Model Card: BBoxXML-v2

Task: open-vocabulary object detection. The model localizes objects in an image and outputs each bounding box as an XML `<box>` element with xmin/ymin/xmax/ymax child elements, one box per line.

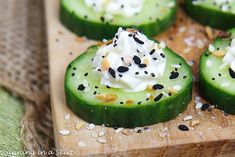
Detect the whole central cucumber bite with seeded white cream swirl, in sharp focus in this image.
<box><xmin>65</xmin><ymin>28</ymin><xmax>192</xmax><ymax>128</ymax></box>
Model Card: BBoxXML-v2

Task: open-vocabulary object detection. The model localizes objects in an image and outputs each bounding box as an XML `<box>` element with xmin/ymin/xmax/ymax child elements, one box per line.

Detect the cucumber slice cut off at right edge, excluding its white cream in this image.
<box><xmin>200</xmin><ymin>29</ymin><xmax>235</xmax><ymax>114</ymax></box>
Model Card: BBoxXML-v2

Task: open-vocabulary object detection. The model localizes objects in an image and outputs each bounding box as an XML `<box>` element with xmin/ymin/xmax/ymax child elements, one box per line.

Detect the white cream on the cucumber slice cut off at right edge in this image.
<box><xmin>221</xmin><ymin>38</ymin><xmax>235</xmax><ymax>71</ymax></box>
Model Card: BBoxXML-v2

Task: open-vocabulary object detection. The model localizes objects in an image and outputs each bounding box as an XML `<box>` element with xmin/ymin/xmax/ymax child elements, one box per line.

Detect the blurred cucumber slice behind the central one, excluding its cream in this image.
<box><xmin>60</xmin><ymin>0</ymin><xmax>176</xmax><ymax>40</ymax></box>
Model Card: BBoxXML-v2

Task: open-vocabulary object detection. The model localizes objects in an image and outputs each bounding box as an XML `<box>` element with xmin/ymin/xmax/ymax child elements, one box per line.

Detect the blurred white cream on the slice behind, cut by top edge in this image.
<box><xmin>85</xmin><ymin>0</ymin><xmax>144</xmax><ymax>18</ymax></box>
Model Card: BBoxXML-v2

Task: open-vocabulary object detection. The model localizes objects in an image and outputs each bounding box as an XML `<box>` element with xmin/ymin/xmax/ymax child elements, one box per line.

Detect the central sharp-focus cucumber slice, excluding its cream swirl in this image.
<box><xmin>65</xmin><ymin>46</ymin><xmax>192</xmax><ymax>128</ymax></box>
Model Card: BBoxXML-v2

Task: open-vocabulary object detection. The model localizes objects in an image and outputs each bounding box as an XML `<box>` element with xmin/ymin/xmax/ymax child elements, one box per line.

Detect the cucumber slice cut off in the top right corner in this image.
<box><xmin>184</xmin><ymin>0</ymin><xmax>235</xmax><ymax>30</ymax></box>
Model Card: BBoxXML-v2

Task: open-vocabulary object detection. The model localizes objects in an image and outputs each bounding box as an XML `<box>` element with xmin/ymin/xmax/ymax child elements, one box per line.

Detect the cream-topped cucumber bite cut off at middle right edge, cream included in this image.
<box><xmin>200</xmin><ymin>29</ymin><xmax>235</xmax><ymax>114</ymax></box>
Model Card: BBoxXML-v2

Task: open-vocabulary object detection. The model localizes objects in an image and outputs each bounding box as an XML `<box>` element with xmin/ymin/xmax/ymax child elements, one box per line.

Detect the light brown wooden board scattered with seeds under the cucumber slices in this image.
<box><xmin>45</xmin><ymin>0</ymin><xmax>235</xmax><ymax>157</ymax></box>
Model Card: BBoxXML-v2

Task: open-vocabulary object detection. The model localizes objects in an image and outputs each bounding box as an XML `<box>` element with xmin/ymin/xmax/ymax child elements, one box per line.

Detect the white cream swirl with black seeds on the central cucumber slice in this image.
<box><xmin>92</xmin><ymin>28</ymin><xmax>166</xmax><ymax>92</ymax></box>
